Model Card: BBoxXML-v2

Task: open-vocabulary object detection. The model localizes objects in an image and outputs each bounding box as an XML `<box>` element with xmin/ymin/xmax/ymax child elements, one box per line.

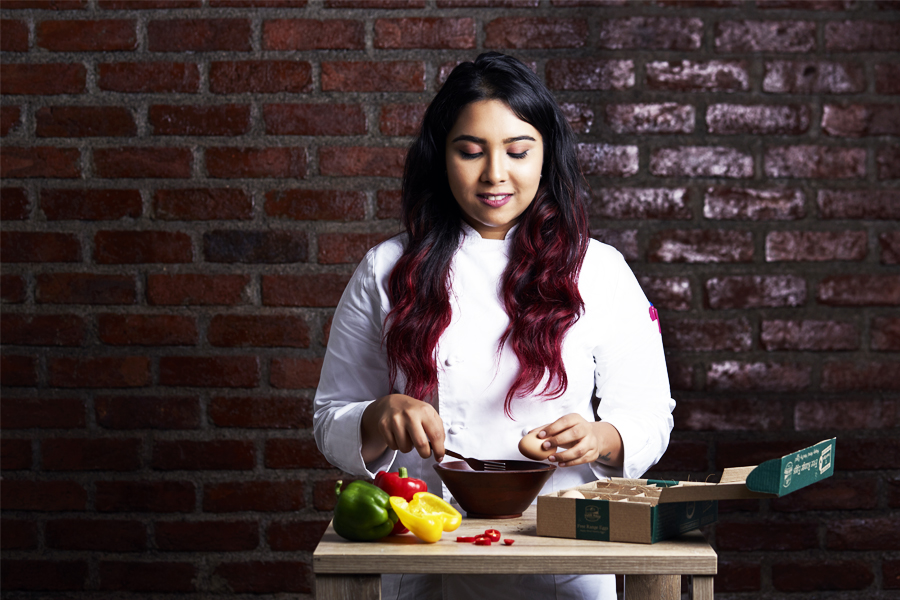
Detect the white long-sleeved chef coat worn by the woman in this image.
<box><xmin>314</xmin><ymin>223</ymin><xmax>675</xmax><ymax>600</ymax></box>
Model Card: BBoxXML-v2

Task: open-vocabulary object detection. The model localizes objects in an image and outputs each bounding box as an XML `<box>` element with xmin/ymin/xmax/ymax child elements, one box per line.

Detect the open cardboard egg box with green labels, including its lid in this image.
<box><xmin>537</xmin><ymin>438</ymin><xmax>836</xmax><ymax>544</ymax></box>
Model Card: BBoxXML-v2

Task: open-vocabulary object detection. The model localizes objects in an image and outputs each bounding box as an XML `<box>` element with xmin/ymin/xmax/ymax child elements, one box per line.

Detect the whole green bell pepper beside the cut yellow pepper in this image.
<box><xmin>334</xmin><ymin>481</ymin><xmax>397</xmax><ymax>542</ymax></box>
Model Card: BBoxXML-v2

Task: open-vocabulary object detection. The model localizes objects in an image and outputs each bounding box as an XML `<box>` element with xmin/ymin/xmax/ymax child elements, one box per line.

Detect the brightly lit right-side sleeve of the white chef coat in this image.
<box><xmin>592</xmin><ymin>247</ymin><xmax>675</xmax><ymax>478</ymax></box>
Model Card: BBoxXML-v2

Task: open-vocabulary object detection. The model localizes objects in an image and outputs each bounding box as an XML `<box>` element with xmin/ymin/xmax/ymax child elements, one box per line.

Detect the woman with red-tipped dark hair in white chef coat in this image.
<box><xmin>314</xmin><ymin>53</ymin><xmax>674</xmax><ymax>599</ymax></box>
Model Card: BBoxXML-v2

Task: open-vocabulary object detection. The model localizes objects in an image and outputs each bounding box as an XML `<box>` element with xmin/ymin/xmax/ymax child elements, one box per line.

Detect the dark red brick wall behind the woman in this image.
<box><xmin>0</xmin><ymin>0</ymin><xmax>900</xmax><ymax>598</ymax></box>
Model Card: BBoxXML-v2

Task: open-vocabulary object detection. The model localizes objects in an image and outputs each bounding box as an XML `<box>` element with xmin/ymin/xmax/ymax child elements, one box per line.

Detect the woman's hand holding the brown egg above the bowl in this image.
<box><xmin>538</xmin><ymin>413</ymin><xmax>623</xmax><ymax>467</ymax></box>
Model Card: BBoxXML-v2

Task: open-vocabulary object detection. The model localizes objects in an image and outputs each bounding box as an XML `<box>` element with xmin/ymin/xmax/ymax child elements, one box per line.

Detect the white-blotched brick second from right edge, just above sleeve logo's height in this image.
<box><xmin>704</xmin><ymin>275</ymin><xmax>806</xmax><ymax>308</ymax></box>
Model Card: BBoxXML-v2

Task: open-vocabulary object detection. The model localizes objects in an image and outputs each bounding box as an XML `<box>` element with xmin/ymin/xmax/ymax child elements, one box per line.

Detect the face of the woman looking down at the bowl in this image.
<box><xmin>446</xmin><ymin>100</ymin><xmax>544</xmax><ymax>240</ymax></box>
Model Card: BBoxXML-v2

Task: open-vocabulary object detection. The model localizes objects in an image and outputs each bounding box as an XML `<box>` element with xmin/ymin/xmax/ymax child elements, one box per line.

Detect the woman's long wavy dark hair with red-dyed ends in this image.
<box><xmin>384</xmin><ymin>52</ymin><xmax>589</xmax><ymax>417</ymax></box>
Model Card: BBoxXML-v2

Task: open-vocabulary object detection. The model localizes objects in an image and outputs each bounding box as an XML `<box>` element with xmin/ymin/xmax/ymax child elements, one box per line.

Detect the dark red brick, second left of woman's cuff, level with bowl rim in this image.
<box><xmin>151</xmin><ymin>440</ymin><xmax>256</xmax><ymax>471</ymax></box>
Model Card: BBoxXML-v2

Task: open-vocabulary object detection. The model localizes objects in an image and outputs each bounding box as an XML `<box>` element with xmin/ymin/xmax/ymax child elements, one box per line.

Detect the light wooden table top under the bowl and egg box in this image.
<box><xmin>313</xmin><ymin>506</ymin><xmax>717</xmax><ymax>575</ymax></box>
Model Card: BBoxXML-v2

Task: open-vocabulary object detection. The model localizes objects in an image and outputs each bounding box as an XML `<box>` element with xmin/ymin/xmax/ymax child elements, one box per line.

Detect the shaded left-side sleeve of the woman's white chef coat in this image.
<box><xmin>313</xmin><ymin>250</ymin><xmax>396</xmax><ymax>477</ymax></box>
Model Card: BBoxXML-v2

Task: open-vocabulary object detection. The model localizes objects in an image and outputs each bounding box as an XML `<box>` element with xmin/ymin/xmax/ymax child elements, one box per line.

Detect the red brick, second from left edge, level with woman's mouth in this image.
<box><xmin>41</xmin><ymin>189</ymin><xmax>142</xmax><ymax>221</ymax></box>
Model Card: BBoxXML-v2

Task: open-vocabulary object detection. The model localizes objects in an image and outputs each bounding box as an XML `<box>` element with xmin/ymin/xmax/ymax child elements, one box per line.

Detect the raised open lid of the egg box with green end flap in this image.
<box><xmin>647</xmin><ymin>438</ymin><xmax>837</xmax><ymax>503</ymax></box>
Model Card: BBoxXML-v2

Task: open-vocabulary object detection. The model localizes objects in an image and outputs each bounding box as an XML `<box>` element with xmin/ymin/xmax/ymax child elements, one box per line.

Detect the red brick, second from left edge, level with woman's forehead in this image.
<box><xmin>34</xmin><ymin>106</ymin><xmax>137</xmax><ymax>137</ymax></box>
